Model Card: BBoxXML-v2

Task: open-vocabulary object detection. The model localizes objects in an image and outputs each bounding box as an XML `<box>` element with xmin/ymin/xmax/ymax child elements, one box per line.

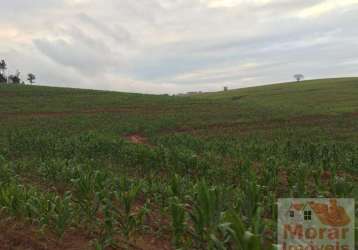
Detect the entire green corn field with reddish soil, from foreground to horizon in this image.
<box><xmin>0</xmin><ymin>78</ymin><xmax>358</xmax><ymax>250</ymax></box>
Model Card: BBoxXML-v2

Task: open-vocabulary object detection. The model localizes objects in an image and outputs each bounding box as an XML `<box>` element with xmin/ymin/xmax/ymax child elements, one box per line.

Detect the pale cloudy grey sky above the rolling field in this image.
<box><xmin>0</xmin><ymin>0</ymin><xmax>358</xmax><ymax>94</ymax></box>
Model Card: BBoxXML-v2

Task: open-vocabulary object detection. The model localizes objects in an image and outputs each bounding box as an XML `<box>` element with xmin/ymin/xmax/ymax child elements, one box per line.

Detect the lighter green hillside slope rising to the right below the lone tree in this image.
<box><xmin>194</xmin><ymin>78</ymin><xmax>358</xmax><ymax>115</ymax></box>
